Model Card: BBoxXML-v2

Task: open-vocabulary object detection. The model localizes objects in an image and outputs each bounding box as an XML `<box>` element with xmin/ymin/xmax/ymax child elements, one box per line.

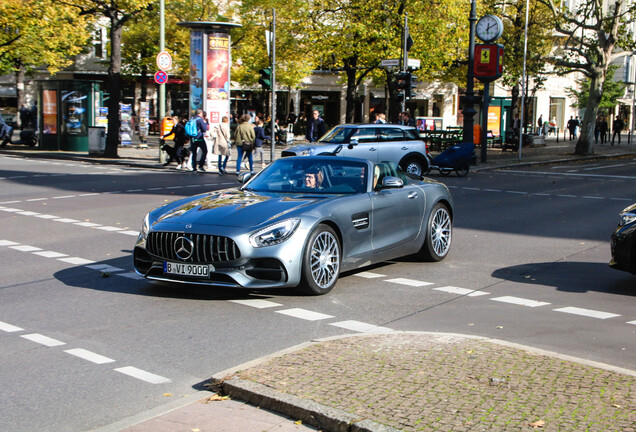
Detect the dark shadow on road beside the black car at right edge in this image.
<box><xmin>492</xmin><ymin>261</ymin><xmax>636</xmax><ymax>297</ymax></box>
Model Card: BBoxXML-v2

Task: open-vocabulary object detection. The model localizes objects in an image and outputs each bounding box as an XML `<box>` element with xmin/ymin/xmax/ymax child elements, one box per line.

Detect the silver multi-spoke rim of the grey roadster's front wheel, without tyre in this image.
<box><xmin>310</xmin><ymin>231</ymin><xmax>340</xmax><ymax>288</ymax></box>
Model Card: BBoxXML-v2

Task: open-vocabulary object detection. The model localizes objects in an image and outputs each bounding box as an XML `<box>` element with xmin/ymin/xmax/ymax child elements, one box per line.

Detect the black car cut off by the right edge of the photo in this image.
<box><xmin>610</xmin><ymin>204</ymin><xmax>636</xmax><ymax>274</ymax></box>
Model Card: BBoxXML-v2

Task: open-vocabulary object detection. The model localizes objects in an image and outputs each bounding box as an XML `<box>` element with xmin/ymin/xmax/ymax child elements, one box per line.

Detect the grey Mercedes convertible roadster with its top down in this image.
<box><xmin>134</xmin><ymin>156</ymin><xmax>453</xmax><ymax>295</ymax></box>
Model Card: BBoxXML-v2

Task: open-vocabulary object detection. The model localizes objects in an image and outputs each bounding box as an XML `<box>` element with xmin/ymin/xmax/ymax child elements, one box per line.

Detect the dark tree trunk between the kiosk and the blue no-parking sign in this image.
<box><xmin>104</xmin><ymin>17</ymin><xmax>123</xmax><ymax>158</ymax></box>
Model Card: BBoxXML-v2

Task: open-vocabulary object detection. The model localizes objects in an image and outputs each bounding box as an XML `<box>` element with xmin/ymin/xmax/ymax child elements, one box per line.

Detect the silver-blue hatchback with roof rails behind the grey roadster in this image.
<box><xmin>281</xmin><ymin>124</ymin><xmax>431</xmax><ymax>176</ymax></box>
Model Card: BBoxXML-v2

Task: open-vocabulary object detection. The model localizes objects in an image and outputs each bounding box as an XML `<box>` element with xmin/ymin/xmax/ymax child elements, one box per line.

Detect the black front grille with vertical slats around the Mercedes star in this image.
<box><xmin>146</xmin><ymin>232</ymin><xmax>241</xmax><ymax>263</ymax></box>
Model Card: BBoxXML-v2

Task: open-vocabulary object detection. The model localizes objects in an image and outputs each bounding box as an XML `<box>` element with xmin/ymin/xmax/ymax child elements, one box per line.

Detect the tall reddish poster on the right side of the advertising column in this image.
<box><xmin>206</xmin><ymin>33</ymin><xmax>230</xmax><ymax>124</ymax></box>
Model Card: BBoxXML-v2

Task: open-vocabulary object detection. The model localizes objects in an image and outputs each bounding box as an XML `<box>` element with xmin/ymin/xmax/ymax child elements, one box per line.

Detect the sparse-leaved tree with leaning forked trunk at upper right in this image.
<box><xmin>540</xmin><ymin>0</ymin><xmax>636</xmax><ymax>155</ymax></box>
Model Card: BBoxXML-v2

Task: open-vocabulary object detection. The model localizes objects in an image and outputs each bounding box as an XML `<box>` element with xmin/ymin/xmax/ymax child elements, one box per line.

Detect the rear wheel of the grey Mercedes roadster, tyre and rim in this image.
<box><xmin>418</xmin><ymin>203</ymin><xmax>453</xmax><ymax>262</ymax></box>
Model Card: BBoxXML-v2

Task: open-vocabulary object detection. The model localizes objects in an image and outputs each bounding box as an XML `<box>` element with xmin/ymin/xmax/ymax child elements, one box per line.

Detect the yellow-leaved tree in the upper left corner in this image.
<box><xmin>0</xmin><ymin>0</ymin><xmax>90</xmax><ymax>122</ymax></box>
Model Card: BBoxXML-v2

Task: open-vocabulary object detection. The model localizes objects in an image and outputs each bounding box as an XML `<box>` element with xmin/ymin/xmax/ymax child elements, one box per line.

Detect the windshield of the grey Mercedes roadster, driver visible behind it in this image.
<box><xmin>245</xmin><ymin>158</ymin><xmax>368</xmax><ymax>194</ymax></box>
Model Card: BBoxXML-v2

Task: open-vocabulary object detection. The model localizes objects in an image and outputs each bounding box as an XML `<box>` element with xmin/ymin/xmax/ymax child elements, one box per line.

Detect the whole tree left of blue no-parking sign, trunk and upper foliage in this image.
<box><xmin>57</xmin><ymin>0</ymin><xmax>153</xmax><ymax>158</ymax></box>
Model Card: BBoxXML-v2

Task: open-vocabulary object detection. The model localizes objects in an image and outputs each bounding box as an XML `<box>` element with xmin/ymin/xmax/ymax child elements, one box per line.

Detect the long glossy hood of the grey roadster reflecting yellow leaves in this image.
<box><xmin>152</xmin><ymin>190</ymin><xmax>328</xmax><ymax>228</ymax></box>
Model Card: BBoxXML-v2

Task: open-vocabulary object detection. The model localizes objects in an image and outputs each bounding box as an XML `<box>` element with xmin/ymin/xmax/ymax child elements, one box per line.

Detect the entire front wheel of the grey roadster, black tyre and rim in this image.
<box><xmin>297</xmin><ymin>225</ymin><xmax>341</xmax><ymax>295</ymax></box>
